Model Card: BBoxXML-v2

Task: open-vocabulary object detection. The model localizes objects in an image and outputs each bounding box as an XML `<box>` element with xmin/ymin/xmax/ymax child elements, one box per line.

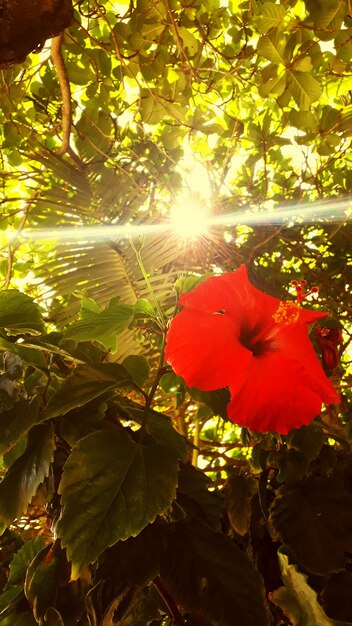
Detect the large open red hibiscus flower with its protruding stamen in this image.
<box><xmin>165</xmin><ymin>265</ymin><xmax>339</xmax><ymax>434</ymax></box>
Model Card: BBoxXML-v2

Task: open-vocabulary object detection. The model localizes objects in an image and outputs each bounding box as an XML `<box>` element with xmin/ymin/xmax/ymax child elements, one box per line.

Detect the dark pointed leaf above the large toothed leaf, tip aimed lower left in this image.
<box><xmin>41</xmin><ymin>363</ymin><xmax>133</xmax><ymax>419</ymax></box>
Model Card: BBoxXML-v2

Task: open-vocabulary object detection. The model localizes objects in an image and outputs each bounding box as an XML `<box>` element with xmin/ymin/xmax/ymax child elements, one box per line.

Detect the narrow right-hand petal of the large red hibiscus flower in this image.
<box><xmin>270</xmin><ymin>322</ymin><xmax>340</xmax><ymax>404</ymax></box>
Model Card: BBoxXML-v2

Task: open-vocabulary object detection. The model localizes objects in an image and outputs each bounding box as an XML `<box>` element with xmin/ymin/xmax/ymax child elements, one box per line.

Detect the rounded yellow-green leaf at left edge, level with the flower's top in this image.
<box><xmin>0</xmin><ymin>289</ymin><xmax>44</xmax><ymax>335</ymax></box>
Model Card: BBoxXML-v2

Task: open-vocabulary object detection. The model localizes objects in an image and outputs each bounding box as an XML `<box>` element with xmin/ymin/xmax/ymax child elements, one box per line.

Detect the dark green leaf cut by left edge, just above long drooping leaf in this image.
<box><xmin>0</xmin><ymin>397</ymin><xmax>40</xmax><ymax>454</ymax></box>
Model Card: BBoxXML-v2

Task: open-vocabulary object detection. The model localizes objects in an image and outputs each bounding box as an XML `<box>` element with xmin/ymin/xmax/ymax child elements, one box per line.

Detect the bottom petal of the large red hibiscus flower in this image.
<box><xmin>227</xmin><ymin>353</ymin><xmax>322</xmax><ymax>435</ymax></box>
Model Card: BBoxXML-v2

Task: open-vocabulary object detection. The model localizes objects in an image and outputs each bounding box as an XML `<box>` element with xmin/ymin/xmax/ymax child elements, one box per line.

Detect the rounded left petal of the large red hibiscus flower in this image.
<box><xmin>165</xmin><ymin>308</ymin><xmax>252</xmax><ymax>391</ymax></box>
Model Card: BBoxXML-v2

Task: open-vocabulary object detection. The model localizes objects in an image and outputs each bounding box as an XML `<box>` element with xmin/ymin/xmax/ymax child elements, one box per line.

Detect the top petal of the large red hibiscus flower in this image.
<box><xmin>180</xmin><ymin>265</ymin><xmax>280</xmax><ymax>330</ymax></box>
